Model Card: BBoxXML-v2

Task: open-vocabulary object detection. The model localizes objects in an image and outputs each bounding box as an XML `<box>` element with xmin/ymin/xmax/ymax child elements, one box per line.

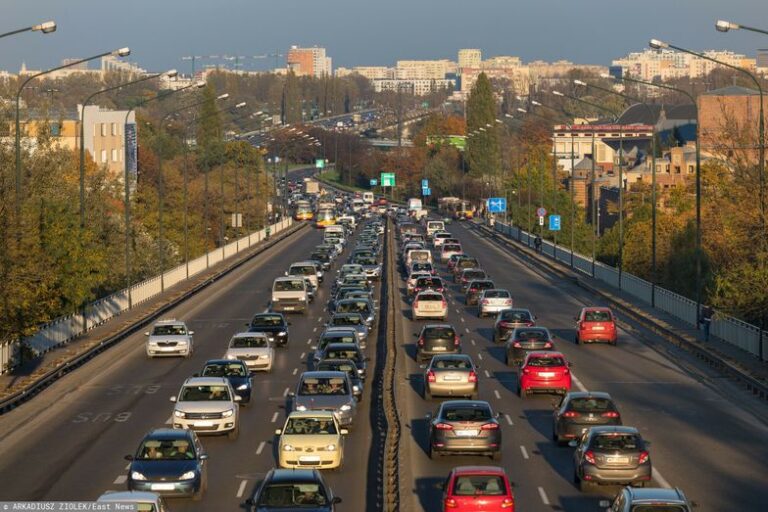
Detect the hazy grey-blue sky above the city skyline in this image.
<box><xmin>0</xmin><ymin>0</ymin><xmax>768</xmax><ymax>73</ymax></box>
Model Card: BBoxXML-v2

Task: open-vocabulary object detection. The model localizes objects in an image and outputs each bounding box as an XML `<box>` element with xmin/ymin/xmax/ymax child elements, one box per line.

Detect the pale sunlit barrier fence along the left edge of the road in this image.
<box><xmin>0</xmin><ymin>219</ymin><xmax>293</xmax><ymax>375</ymax></box>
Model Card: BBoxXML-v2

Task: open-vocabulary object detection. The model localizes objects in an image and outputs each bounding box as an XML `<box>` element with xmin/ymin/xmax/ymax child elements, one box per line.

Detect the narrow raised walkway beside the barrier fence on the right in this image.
<box><xmin>468</xmin><ymin>222</ymin><xmax>768</xmax><ymax>385</ymax></box>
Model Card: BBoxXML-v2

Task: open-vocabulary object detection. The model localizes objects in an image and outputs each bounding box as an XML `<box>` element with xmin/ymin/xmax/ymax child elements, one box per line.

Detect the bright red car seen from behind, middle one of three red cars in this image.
<box><xmin>517</xmin><ymin>351</ymin><xmax>571</xmax><ymax>398</ymax></box>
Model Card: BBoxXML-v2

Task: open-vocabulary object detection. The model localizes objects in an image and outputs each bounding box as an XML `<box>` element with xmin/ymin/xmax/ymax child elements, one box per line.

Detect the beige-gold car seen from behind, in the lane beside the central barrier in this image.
<box><xmin>424</xmin><ymin>354</ymin><xmax>478</xmax><ymax>400</ymax></box>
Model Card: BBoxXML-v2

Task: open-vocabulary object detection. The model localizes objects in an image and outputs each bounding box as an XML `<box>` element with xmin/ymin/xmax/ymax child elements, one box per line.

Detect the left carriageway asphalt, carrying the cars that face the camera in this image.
<box><xmin>0</xmin><ymin>222</ymin><xmax>375</xmax><ymax>511</ymax></box>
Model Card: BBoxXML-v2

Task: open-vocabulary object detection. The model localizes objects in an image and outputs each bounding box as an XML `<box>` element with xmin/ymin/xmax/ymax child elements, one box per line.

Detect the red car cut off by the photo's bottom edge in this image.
<box><xmin>443</xmin><ymin>466</ymin><xmax>515</xmax><ymax>512</ymax></box>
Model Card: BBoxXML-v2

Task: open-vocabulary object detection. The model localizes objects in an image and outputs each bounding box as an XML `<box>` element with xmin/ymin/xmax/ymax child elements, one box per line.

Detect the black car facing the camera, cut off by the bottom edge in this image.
<box><xmin>244</xmin><ymin>469</ymin><xmax>341</xmax><ymax>512</ymax></box>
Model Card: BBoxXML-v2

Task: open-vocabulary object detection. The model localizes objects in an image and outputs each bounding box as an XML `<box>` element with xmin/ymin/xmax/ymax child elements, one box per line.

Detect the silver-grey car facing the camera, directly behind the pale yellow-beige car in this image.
<box><xmin>288</xmin><ymin>371</ymin><xmax>357</xmax><ymax>427</ymax></box>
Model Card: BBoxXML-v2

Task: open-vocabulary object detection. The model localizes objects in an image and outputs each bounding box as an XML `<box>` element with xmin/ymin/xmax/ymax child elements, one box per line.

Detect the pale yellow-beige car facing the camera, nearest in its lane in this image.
<box><xmin>275</xmin><ymin>411</ymin><xmax>348</xmax><ymax>469</ymax></box>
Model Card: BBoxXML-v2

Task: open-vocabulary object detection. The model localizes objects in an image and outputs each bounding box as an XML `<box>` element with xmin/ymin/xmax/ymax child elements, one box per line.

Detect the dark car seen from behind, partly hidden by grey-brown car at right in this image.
<box><xmin>552</xmin><ymin>391</ymin><xmax>621</xmax><ymax>443</ymax></box>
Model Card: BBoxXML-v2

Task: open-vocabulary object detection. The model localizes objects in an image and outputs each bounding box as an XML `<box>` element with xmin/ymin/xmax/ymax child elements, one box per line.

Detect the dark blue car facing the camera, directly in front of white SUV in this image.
<box><xmin>125</xmin><ymin>428</ymin><xmax>208</xmax><ymax>501</ymax></box>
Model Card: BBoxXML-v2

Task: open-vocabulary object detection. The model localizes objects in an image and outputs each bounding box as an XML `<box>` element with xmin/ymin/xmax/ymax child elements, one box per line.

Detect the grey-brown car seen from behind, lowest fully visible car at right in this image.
<box><xmin>570</xmin><ymin>426</ymin><xmax>652</xmax><ymax>491</ymax></box>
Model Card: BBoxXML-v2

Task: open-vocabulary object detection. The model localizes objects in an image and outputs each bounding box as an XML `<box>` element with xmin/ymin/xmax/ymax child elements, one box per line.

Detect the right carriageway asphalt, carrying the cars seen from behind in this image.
<box><xmin>394</xmin><ymin>223</ymin><xmax>768</xmax><ymax>512</ymax></box>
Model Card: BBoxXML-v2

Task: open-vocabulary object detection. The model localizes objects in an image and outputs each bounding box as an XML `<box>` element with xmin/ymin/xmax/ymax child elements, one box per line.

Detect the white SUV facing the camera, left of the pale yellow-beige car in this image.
<box><xmin>171</xmin><ymin>377</ymin><xmax>240</xmax><ymax>439</ymax></box>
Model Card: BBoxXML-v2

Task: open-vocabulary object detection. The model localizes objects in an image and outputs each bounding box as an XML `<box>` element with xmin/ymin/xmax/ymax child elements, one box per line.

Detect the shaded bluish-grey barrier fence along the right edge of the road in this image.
<box><xmin>494</xmin><ymin>222</ymin><xmax>768</xmax><ymax>361</ymax></box>
